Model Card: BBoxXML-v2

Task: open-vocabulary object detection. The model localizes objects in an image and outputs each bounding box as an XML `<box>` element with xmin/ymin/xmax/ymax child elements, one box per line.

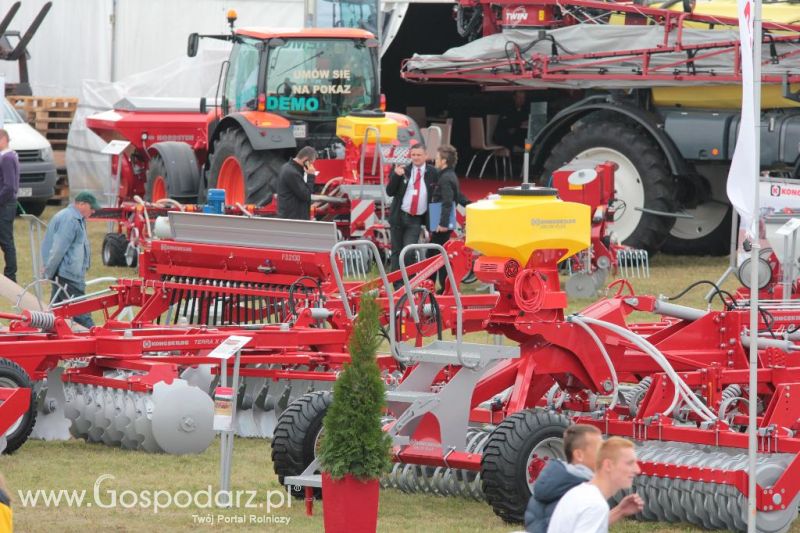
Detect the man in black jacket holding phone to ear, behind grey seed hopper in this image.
<box><xmin>278</xmin><ymin>146</ymin><xmax>317</xmax><ymax>220</ymax></box>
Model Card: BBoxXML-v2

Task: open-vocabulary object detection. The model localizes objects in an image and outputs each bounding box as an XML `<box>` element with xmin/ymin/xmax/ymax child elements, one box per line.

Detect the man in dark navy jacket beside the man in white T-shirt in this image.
<box><xmin>525</xmin><ymin>424</ymin><xmax>644</xmax><ymax>533</ymax></box>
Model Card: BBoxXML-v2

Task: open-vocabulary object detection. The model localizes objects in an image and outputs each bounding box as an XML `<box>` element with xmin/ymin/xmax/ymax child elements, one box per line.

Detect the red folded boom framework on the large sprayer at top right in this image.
<box><xmin>401</xmin><ymin>0</ymin><xmax>800</xmax><ymax>85</ymax></box>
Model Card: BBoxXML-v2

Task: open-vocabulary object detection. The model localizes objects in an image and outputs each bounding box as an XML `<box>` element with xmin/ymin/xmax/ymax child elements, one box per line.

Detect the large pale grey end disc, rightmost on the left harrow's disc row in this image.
<box><xmin>151</xmin><ymin>379</ymin><xmax>214</xmax><ymax>455</ymax></box>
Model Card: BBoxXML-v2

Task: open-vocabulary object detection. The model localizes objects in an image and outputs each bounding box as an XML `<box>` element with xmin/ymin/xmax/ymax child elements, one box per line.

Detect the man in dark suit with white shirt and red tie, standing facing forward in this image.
<box><xmin>386</xmin><ymin>144</ymin><xmax>439</xmax><ymax>271</ymax></box>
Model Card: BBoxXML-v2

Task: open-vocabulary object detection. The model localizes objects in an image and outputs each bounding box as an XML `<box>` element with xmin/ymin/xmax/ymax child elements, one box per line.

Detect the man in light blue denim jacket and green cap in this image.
<box><xmin>42</xmin><ymin>192</ymin><xmax>100</xmax><ymax>328</ymax></box>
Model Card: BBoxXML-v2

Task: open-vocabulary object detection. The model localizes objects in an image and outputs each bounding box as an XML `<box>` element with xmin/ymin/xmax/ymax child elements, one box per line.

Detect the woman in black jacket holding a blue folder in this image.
<box><xmin>428</xmin><ymin>144</ymin><xmax>461</xmax><ymax>294</ymax></box>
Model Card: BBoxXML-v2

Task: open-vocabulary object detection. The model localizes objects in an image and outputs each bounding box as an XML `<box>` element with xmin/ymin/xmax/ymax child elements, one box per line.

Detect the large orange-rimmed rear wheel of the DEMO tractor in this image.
<box><xmin>208</xmin><ymin>128</ymin><xmax>285</xmax><ymax>206</ymax></box>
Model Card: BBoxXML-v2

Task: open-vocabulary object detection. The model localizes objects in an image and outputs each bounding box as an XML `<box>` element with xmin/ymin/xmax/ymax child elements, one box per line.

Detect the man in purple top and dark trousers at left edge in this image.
<box><xmin>0</xmin><ymin>129</ymin><xmax>19</xmax><ymax>281</ymax></box>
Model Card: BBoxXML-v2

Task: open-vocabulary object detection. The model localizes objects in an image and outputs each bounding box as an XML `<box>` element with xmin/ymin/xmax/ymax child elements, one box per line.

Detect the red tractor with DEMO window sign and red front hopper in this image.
<box><xmin>87</xmin><ymin>12</ymin><xmax>420</xmax><ymax>264</ymax></box>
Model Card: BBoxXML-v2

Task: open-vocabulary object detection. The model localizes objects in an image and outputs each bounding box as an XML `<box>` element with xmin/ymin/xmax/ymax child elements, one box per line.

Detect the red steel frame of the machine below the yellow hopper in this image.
<box><xmin>394</xmin><ymin>239</ymin><xmax>800</xmax><ymax>511</ymax></box>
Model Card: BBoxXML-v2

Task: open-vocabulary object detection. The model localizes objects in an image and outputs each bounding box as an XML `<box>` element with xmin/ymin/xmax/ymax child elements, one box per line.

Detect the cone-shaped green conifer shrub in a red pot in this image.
<box><xmin>318</xmin><ymin>297</ymin><xmax>391</xmax><ymax>533</ymax></box>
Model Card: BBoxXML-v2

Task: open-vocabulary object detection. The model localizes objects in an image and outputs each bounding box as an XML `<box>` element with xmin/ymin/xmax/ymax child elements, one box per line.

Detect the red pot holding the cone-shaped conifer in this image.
<box><xmin>322</xmin><ymin>472</ymin><xmax>380</xmax><ymax>533</ymax></box>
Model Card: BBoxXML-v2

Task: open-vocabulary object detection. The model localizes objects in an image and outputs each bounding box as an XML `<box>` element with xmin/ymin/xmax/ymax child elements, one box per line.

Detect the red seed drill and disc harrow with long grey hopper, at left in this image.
<box><xmin>0</xmin><ymin>211</ymin><xmax>504</xmax><ymax>453</ymax></box>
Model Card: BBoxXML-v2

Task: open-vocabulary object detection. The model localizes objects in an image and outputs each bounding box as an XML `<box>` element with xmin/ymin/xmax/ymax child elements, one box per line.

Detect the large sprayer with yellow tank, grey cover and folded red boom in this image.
<box><xmin>402</xmin><ymin>0</ymin><xmax>800</xmax><ymax>255</ymax></box>
